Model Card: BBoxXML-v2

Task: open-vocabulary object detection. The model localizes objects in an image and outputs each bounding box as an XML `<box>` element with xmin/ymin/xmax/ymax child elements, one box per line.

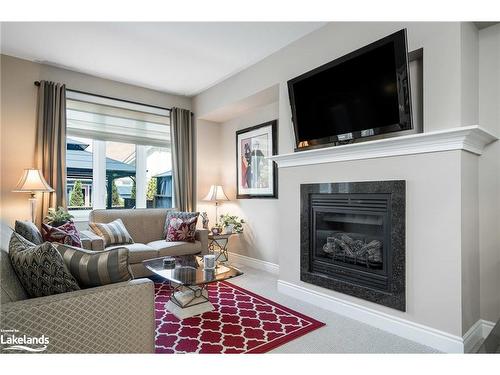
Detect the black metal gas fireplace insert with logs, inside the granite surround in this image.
<box><xmin>309</xmin><ymin>193</ymin><xmax>391</xmax><ymax>291</ymax></box>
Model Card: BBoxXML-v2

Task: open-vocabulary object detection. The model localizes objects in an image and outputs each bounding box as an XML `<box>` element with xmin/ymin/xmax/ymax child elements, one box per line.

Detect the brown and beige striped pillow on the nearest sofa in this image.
<box><xmin>55</xmin><ymin>244</ymin><xmax>132</xmax><ymax>288</ymax></box>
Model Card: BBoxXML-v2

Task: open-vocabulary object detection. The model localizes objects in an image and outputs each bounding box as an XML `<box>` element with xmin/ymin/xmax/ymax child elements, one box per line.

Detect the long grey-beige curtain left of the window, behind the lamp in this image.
<box><xmin>35</xmin><ymin>81</ymin><xmax>66</xmax><ymax>225</ymax></box>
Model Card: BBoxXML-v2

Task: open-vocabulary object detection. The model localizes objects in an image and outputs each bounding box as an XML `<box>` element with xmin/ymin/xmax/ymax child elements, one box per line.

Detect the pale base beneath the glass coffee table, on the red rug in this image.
<box><xmin>165</xmin><ymin>284</ymin><xmax>215</xmax><ymax>319</ymax></box>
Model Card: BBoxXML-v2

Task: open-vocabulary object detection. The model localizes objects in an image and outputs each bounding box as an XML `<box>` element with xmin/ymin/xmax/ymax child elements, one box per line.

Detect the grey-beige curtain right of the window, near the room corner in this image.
<box><xmin>170</xmin><ymin>108</ymin><xmax>196</xmax><ymax>212</ymax></box>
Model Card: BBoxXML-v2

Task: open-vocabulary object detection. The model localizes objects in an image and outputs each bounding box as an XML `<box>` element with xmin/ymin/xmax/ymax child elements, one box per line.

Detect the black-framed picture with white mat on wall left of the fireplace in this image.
<box><xmin>236</xmin><ymin>120</ymin><xmax>278</xmax><ymax>199</ymax></box>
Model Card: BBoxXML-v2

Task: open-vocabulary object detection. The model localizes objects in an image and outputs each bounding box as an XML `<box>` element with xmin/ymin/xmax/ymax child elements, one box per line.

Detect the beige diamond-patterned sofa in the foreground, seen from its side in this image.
<box><xmin>0</xmin><ymin>226</ymin><xmax>155</xmax><ymax>353</ymax></box>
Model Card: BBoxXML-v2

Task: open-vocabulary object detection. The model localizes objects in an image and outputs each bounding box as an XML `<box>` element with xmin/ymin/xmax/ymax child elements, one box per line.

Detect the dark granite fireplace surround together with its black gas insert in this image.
<box><xmin>300</xmin><ymin>180</ymin><xmax>406</xmax><ymax>311</ymax></box>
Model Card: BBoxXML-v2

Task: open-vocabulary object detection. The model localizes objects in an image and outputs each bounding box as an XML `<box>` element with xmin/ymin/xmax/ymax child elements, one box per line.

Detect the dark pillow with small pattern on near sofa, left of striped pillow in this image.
<box><xmin>9</xmin><ymin>233</ymin><xmax>80</xmax><ymax>297</ymax></box>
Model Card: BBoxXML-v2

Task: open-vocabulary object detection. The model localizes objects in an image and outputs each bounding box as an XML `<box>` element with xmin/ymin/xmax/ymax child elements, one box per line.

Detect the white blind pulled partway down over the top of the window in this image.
<box><xmin>66</xmin><ymin>91</ymin><xmax>171</xmax><ymax>148</ymax></box>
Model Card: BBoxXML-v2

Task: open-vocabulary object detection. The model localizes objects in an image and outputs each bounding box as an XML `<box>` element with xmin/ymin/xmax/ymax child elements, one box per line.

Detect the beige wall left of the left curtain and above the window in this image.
<box><xmin>0</xmin><ymin>55</ymin><xmax>191</xmax><ymax>225</ymax></box>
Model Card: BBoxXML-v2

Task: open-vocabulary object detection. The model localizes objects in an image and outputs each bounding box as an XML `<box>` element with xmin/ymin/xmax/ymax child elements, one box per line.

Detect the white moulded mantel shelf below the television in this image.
<box><xmin>269</xmin><ymin>125</ymin><xmax>498</xmax><ymax>168</ymax></box>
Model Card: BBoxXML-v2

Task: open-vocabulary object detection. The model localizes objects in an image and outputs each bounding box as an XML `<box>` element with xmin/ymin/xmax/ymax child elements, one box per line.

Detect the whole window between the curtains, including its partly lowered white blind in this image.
<box><xmin>66</xmin><ymin>90</ymin><xmax>172</xmax><ymax>212</ymax></box>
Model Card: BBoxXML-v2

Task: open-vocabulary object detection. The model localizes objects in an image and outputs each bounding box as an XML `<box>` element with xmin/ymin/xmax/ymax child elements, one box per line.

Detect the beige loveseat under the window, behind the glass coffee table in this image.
<box><xmin>82</xmin><ymin>208</ymin><xmax>208</xmax><ymax>278</ymax></box>
